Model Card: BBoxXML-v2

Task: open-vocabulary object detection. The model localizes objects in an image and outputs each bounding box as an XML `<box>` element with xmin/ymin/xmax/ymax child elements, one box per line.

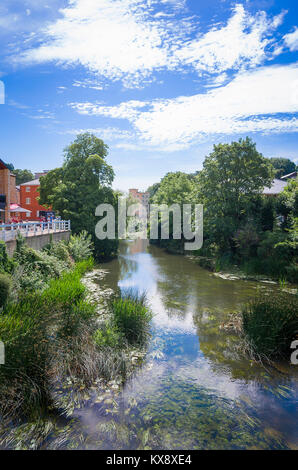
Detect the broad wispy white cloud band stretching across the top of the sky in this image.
<box><xmin>16</xmin><ymin>0</ymin><xmax>284</xmax><ymax>87</ymax></box>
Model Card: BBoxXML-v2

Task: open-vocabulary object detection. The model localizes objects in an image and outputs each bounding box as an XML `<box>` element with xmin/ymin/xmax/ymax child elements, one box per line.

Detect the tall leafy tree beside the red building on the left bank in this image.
<box><xmin>40</xmin><ymin>133</ymin><xmax>118</xmax><ymax>258</ymax></box>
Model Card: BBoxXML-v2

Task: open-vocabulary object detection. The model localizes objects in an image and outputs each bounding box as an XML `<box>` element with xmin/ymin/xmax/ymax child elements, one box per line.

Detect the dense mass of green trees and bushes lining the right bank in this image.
<box><xmin>151</xmin><ymin>138</ymin><xmax>298</xmax><ymax>282</ymax></box>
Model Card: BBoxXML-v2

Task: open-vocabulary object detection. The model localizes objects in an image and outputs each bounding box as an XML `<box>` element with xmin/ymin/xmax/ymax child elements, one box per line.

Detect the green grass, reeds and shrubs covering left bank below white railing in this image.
<box><xmin>0</xmin><ymin>235</ymin><xmax>151</xmax><ymax>440</ymax></box>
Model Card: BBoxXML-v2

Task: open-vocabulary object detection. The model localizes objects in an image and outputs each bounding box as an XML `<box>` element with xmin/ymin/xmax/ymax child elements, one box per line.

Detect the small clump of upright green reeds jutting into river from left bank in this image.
<box><xmin>111</xmin><ymin>291</ymin><xmax>152</xmax><ymax>345</ymax></box>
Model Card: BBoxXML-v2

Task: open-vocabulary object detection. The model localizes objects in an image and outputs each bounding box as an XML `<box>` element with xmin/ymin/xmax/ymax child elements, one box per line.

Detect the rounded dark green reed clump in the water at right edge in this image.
<box><xmin>242</xmin><ymin>292</ymin><xmax>298</xmax><ymax>359</ymax></box>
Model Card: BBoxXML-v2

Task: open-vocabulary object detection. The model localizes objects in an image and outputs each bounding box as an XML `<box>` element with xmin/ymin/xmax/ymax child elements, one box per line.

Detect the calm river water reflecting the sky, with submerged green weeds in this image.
<box><xmin>71</xmin><ymin>240</ymin><xmax>298</xmax><ymax>449</ymax></box>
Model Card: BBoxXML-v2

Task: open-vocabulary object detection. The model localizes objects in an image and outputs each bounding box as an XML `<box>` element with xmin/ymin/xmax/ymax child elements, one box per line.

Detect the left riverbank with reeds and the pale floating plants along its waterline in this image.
<box><xmin>0</xmin><ymin>237</ymin><xmax>151</xmax><ymax>449</ymax></box>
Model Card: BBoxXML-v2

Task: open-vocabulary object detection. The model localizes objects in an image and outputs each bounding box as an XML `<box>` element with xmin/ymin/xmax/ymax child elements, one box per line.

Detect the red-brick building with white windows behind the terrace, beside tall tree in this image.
<box><xmin>20</xmin><ymin>178</ymin><xmax>49</xmax><ymax>220</ymax></box>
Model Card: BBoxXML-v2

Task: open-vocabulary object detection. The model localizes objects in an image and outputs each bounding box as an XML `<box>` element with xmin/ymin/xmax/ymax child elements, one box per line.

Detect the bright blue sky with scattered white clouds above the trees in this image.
<box><xmin>0</xmin><ymin>0</ymin><xmax>298</xmax><ymax>190</ymax></box>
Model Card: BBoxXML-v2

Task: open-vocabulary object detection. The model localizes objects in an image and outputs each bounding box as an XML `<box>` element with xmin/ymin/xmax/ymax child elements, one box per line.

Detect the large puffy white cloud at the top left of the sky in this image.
<box><xmin>18</xmin><ymin>0</ymin><xmax>175</xmax><ymax>86</ymax></box>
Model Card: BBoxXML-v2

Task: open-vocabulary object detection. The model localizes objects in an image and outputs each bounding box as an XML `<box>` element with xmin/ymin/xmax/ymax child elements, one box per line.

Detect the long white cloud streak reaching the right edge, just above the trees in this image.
<box><xmin>71</xmin><ymin>64</ymin><xmax>298</xmax><ymax>150</ymax></box>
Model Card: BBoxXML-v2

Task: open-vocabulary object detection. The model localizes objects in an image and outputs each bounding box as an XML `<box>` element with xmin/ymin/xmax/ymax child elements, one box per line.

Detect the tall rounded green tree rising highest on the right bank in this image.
<box><xmin>196</xmin><ymin>137</ymin><xmax>273</xmax><ymax>251</ymax></box>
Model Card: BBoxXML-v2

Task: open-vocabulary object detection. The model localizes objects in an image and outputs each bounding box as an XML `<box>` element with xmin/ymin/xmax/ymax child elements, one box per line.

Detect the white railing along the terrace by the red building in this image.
<box><xmin>0</xmin><ymin>220</ymin><xmax>71</xmax><ymax>241</ymax></box>
